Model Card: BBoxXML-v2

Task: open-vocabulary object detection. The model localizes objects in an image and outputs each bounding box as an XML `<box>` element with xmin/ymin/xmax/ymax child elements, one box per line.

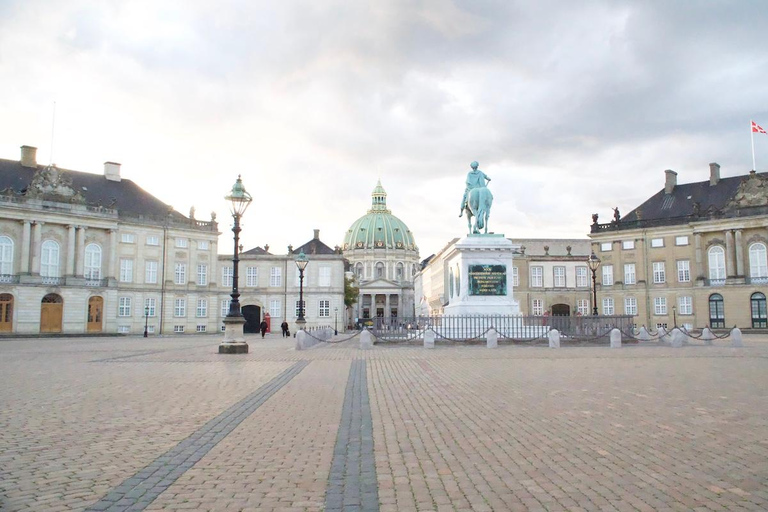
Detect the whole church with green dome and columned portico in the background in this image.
<box><xmin>342</xmin><ymin>180</ymin><xmax>419</xmax><ymax>322</ymax></box>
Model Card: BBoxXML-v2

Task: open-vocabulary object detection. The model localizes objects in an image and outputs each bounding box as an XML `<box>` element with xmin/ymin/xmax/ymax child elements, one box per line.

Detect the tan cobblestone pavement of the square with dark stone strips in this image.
<box><xmin>0</xmin><ymin>335</ymin><xmax>768</xmax><ymax>511</ymax></box>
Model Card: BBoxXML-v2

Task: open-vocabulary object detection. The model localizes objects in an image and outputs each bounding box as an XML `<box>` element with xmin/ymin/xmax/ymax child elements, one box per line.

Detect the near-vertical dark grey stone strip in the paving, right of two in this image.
<box><xmin>325</xmin><ymin>359</ymin><xmax>379</xmax><ymax>512</ymax></box>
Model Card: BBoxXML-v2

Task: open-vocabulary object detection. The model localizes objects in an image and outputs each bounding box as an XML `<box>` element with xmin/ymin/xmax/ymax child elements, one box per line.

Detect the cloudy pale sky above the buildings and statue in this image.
<box><xmin>0</xmin><ymin>0</ymin><xmax>768</xmax><ymax>257</ymax></box>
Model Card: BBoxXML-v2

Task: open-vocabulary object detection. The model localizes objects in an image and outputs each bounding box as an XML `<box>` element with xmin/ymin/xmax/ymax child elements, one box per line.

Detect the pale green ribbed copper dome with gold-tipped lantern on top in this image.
<box><xmin>343</xmin><ymin>180</ymin><xmax>416</xmax><ymax>251</ymax></box>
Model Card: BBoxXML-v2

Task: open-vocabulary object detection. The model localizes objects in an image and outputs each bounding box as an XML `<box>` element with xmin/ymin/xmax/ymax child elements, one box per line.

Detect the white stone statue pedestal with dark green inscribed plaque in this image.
<box><xmin>443</xmin><ymin>234</ymin><xmax>520</xmax><ymax>316</ymax></box>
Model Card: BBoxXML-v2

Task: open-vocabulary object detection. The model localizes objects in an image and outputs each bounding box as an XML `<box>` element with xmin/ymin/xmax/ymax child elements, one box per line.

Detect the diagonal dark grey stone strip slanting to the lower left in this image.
<box><xmin>86</xmin><ymin>361</ymin><xmax>309</xmax><ymax>512</ymax></box>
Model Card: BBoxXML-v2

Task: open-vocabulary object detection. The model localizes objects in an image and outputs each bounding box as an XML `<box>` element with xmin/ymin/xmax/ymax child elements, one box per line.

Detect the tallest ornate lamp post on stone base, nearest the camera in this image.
<box><xmin>219</xmin><ymin>175</ymin><xmax>253</xmax><ymax>354</ymax></box>
